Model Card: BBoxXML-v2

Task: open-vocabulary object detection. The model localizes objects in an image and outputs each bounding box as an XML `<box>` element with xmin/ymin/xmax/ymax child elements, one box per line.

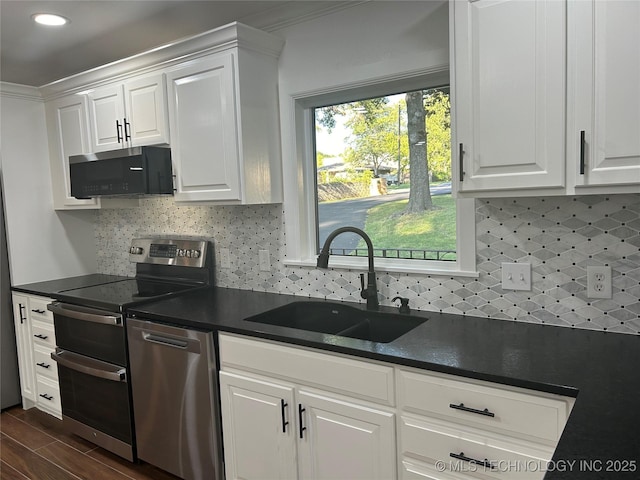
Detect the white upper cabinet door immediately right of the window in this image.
<box><xmin>452</xmin><ymin>0</ymin><xmax>566</xmax><ymax>194</ymax></box>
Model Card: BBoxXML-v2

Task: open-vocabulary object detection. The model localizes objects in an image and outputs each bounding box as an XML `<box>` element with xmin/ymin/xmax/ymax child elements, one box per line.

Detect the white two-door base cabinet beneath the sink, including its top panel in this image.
<box><xmin>220</xmin><ymin>335</ymin><xmax>397</xmax><ymax>480</ymax></box>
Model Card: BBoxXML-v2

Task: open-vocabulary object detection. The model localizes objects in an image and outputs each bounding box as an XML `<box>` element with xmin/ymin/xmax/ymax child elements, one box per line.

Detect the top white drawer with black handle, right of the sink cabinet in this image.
<box><xmin>397</xmin><ymin>370</ymin><xmax>573</xmax><ymax>445</ymax></box>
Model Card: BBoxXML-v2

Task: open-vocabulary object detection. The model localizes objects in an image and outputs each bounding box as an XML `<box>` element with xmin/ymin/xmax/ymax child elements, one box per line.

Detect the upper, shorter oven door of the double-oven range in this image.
<box><xmin>47</xmin><ymin>302</ymin><xmax>127</xmax><ymax>366</ymax></box>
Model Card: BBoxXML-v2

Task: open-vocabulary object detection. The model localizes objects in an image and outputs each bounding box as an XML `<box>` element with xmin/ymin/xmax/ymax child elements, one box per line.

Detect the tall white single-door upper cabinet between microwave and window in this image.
<box><xmin>166</xmin><ymin>24</ymin><xmax>282</xmax><ymax>204</ymax></box>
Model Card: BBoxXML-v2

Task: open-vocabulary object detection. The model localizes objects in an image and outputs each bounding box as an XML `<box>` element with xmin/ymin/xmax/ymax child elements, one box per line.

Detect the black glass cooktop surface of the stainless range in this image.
<box><xmin>56</xmin><ymin>278</ymin><xmax>199</xmax><ymax>311</ymax></box>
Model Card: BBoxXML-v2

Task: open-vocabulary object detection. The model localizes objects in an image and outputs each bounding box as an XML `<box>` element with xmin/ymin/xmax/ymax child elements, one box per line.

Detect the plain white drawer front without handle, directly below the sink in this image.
<box><xmin>219</xmin><ymin>334</ymin><xmax>394</xmax><ymax>405</ymax></box>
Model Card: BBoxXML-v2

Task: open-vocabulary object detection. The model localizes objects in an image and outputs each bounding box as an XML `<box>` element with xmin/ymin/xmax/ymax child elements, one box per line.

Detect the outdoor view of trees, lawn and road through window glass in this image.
<box><xmin>314</xmin><ymin>87</ymin><xmax>456</xmax><ymax>261</ymax></box>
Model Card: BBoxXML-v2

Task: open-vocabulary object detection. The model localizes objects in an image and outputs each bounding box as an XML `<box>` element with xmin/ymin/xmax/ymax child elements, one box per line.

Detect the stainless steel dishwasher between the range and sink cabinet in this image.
<box><xmin>127</xmin><ymin>318</ymin><xmax>223</xmax><ymax>480</ymax></box>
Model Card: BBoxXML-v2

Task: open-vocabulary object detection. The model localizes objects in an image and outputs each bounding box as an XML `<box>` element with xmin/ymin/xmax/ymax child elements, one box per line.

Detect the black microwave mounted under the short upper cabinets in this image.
<box><xmin>69</xmin><ymin>146</ymin><xmax>173</xmax><ymax>198</ymax></box>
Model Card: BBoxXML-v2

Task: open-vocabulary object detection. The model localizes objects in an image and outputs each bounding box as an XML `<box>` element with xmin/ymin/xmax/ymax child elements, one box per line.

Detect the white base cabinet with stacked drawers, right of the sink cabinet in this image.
<box><xmin>396</xmin><ymin>368</ymin><xmax>574</xmax><ymax>480</ymax></box>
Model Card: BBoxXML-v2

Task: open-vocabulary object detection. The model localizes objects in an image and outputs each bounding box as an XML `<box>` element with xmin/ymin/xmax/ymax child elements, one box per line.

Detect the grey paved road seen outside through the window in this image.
<box><xmin>318</xmin><ymin>183</ymin><xmax>451</xmax><ymax>249</ymax></box>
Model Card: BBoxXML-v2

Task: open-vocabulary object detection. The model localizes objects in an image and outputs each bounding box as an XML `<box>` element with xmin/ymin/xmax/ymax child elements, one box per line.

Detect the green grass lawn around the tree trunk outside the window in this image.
<box><xmin>358</xmin><ymin>195</ymin><xmax>456</xmax><ymax>260</ymax></box>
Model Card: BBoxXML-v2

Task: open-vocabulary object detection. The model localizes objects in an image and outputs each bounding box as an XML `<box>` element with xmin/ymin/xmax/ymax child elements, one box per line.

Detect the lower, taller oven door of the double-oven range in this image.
<box><xmin>51</xmin><ymin>348</ymin><xmax>133</xmax><ymax>460</ymax></box>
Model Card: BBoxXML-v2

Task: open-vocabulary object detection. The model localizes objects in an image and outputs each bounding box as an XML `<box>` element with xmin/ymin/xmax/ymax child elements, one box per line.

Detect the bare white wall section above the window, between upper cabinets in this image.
<box><xmin>275</xmin><ymin>1</ymin><xmax>449</xmax><ymax>98</ymax></box>
